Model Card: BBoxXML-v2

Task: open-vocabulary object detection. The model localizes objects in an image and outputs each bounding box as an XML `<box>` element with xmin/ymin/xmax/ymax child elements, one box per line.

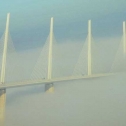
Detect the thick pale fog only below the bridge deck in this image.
<box><xmin>6</xmin><ymin>74</ymin><xmax>126</xmax><ymax>126</ymax></box>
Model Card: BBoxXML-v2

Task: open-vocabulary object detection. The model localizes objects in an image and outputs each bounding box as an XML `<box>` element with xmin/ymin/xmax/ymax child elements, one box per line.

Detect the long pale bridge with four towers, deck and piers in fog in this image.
<box><xmin>0</xmin><ymin>13</ymin><xmax>126</xmax><ymax>126</ymax></box>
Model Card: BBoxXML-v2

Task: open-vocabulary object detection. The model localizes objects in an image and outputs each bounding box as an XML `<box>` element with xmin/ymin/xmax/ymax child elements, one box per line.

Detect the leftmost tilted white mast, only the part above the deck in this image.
<box><xmin>1</xmin><ymin>13</ymin><xmax>10</xmax><ymax>83</ymax></box>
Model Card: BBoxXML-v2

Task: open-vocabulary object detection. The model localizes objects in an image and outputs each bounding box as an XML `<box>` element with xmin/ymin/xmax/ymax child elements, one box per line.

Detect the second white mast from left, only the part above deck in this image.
<box><xmin>48</xmin><ymin>17</ymin><xmax>53</xmax><ymax>79</ymax></box>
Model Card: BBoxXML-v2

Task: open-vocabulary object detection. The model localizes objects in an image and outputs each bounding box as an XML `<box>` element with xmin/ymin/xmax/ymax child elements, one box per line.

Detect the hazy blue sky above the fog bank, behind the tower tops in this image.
<box><xmin>0</xmin><ymin>0</ymin><xmax>126</xmax><ymax>47</ymax></box>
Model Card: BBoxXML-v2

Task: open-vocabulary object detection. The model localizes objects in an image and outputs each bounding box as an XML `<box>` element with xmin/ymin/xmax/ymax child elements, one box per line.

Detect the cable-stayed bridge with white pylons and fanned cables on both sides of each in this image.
<box><xmin>0</xmin><ymin>13</ymin><xmax>126</xmax><ymax>126</ymax></box>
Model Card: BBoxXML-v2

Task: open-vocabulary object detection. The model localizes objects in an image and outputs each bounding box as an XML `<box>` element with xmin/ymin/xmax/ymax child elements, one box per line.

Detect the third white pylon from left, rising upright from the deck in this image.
<box><xmin>88</xmin><ymin>20</ymin><xmax>92</xmax><ymax>76</ymax></box>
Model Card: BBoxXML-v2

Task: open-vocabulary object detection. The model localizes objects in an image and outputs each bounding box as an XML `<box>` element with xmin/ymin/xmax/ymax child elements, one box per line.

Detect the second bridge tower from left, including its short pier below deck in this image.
<box><xmin>45</xmin><ymin>17</ymin><xmax>54</xmax><ymax>92</ymax></box>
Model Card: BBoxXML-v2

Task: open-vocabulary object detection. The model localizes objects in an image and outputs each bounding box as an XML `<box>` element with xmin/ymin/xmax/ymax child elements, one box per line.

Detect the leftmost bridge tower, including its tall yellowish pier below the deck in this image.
<box><xmin>0</xmin><ymin>13</ymin><xmax>10</xmax><ymax>126</ymax></box>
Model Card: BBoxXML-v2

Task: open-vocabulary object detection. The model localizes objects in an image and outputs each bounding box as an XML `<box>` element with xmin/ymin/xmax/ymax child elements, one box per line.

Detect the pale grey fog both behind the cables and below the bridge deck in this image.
<box><xmin>3</xmin><ymin>37</ymin><xmax>126</xmax><ymax>126</ymax></box>
